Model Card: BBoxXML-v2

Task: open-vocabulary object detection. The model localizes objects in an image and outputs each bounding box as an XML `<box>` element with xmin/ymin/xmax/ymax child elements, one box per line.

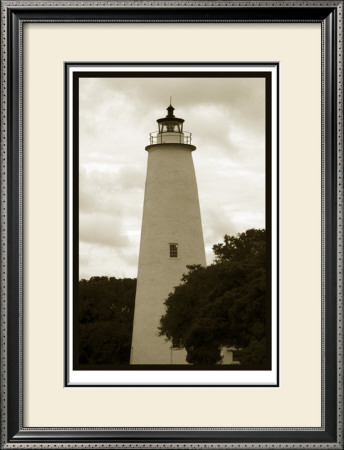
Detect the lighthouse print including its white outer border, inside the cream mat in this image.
<box><xmin>65</xmin><ymin>63</ymin><xmax>278</xmax><ymax>386</ymax></box>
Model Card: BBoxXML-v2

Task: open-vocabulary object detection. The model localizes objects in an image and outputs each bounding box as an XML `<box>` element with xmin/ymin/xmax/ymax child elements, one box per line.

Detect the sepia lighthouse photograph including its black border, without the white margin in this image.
<box><xmin>68</xmin><ymin>67</ymin><xmax>276</xmax><ymax>380</ymax></box>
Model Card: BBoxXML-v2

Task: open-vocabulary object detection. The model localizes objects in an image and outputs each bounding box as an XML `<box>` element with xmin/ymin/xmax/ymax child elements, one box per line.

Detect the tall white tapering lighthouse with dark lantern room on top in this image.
<box><xmin>130</xmin><ymin>105</ymin><xmax>206</xmax><ymax>364</ymax></box>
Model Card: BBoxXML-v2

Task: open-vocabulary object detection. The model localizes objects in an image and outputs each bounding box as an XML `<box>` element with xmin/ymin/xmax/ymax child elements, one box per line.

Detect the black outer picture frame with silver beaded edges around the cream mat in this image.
<box><xmin>1</xmin><ymin>0</ymin><xmax>343</xmax><ymax>449</ymax></box>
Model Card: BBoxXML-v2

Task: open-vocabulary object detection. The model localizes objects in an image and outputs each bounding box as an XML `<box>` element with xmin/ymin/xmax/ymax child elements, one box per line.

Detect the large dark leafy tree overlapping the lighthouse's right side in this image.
<box><xmin>159</xmin><ymin>229</ymin><xmax>266</xmax><ymax>365</ymax></box>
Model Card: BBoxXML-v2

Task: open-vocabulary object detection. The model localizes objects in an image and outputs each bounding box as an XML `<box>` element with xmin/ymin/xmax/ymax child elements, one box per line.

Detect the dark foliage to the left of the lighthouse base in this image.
<box><xmin>78</xmin><ymin>277</ymin><xmax>136</xmax><ymax>364</ymax></box>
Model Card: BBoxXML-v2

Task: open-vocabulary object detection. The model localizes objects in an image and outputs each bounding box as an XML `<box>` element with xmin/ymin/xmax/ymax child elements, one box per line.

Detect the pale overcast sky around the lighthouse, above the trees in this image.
<box><xmin>79</xmin><ymin>78</ymin><xmax>265</xmax><ymax>279</ymax></box>
